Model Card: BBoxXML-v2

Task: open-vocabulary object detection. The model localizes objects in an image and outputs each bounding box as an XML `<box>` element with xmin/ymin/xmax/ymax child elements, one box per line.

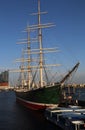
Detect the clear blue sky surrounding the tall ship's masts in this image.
<box><xmin>0</xmin><ymin>0</ymin><xmax>85</xmax><ymax>83</ymax></box>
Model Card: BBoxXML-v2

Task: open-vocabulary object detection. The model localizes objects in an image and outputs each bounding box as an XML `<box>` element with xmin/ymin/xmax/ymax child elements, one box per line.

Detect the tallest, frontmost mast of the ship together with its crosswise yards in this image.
<box><xmin>30</xmin><ymin>0</ymin><xmax>59</xmax><ymax>87</ymax></box>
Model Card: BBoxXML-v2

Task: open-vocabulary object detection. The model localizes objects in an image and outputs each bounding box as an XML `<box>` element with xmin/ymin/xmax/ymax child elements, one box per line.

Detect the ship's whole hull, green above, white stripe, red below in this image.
<box><xmin>15</xmin><ymin>86</ymin><xmax>60</xmax><ymax>110</ymax></box>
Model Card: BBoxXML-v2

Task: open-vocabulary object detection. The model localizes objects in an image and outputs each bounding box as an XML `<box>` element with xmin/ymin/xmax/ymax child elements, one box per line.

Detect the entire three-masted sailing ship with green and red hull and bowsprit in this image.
<box><xmin>15</xmin><ymin>0</ymin><xmax>79</xmax><ymax>110</ymax></box>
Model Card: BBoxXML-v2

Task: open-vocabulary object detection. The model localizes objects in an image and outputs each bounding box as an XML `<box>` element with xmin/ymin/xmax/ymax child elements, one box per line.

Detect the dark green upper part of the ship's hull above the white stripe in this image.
<box><xmin>16</xmin><ymin>86</ymin><xmax>61</xmax><ymax>104</ymax></box>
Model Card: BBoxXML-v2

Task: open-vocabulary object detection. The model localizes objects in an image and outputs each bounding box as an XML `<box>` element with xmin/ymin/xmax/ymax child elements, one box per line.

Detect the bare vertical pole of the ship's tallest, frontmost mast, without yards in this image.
<box><xmin>38</xmin><ymin>0</ymin><xmax>43</xmax><ymax>87</ymax></box>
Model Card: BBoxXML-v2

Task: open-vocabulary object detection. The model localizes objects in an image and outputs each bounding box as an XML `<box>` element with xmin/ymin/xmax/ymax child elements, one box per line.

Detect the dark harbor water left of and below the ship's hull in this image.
<box><xmin>0</xmin><ymin>91</ymin><xmax>60</xmax><ymax>130</ymax></box>
